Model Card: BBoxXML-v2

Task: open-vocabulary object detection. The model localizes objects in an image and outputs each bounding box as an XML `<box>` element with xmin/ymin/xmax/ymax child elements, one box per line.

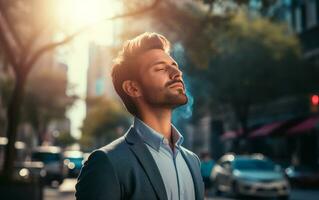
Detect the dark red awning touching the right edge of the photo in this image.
<box><xmin>287</xmin><ymin>116</ymin><xmax>319</xmax><ymax>135</ymax></box>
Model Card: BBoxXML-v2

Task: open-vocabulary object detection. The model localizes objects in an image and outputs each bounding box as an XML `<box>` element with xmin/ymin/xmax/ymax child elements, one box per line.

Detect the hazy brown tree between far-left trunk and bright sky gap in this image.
<box><xmin>22</xmin><ymin>63</ymin><xmax>78</xmax><ymax>144</ymax></box>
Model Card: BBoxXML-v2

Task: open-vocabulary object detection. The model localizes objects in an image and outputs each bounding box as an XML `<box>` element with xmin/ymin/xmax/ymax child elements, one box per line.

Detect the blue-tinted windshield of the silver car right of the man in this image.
<box><xmin>233</xmin><ymin>158</ymin><xmax>276</xmax><ymax>170</ymax></box>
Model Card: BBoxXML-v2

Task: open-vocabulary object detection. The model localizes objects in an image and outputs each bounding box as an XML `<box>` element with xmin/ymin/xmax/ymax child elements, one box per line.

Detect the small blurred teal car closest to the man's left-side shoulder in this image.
<box><xmin>63</xmin><ymin>151</ymin><xmax>84</xmax><ymax>177</ymax></box>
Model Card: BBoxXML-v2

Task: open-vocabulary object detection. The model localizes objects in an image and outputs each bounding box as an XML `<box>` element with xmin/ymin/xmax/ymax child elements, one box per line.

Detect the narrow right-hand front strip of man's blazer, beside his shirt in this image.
<box><xmin>181</xmin><ymin>148</ymin><xmax>204</xmax><ymax>200</ymax></box>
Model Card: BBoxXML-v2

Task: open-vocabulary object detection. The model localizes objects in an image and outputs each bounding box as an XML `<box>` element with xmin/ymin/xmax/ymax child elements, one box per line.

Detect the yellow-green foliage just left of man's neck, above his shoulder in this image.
<box><xmin>80</xmin><ymin>97</ymin><xmax>130</xmax><ymax>146</ymax></box>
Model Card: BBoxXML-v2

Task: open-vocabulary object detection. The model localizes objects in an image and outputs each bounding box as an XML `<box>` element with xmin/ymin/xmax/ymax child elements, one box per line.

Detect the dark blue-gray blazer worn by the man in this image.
<box><xmin>75</xmin><ymin>128</ymin><xmax>204</xmax><ymax>200</ymax></box>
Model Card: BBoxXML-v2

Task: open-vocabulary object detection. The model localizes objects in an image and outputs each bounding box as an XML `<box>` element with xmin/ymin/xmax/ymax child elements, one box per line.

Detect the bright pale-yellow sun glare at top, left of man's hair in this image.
<box><xmin>56</xmin><ymin>0</ymin><xmax>121</xmax><ymax>43</ymax></box>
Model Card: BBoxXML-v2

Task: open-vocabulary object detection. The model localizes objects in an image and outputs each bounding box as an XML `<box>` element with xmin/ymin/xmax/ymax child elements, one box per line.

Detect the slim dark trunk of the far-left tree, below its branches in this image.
<box><xmin>3</xmin><ymin>75</ymin><xmax>25</xmax><ymax>180</ymax></box>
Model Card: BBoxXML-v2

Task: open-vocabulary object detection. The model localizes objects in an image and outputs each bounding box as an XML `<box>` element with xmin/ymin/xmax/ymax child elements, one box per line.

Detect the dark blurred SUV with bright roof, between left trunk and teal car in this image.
<box><xmin>32</xmin><ymin>146</ymin><xmax>66</xmax><ymax>184</ymax></box>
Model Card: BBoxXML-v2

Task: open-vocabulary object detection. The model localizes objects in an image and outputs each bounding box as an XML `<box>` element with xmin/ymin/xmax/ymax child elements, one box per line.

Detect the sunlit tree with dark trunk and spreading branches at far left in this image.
<box><xmin>0</xmin><ymin>0</ymin><xmax>160</xmax><ymax>179</ymax></box>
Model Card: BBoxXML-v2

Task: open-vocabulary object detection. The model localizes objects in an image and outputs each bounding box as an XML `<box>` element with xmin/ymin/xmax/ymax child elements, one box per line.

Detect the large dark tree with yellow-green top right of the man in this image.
<box><xmin>203</xmin><ymin>13</ymin><xmax>317</xmax><ymax>135</ymax></box>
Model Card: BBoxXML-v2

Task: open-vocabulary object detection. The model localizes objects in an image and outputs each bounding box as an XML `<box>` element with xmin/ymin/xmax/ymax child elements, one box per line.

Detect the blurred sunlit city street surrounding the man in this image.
<box><xmin>0</xmin><ymin>0</ymin><xmax>319</xmax><ymax>200</ymax></box>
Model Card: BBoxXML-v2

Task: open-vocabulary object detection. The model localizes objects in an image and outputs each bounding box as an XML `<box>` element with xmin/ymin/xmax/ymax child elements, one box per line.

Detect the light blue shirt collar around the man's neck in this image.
<box><xmin>133</xmin><ymin>117</ymin><xmax>184</xmax><ymax>151</ymax></box>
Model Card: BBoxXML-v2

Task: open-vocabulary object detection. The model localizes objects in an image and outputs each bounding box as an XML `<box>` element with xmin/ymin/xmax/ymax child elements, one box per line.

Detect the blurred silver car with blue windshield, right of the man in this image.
<box><xmin>211</xmin><ymin>154</ymin><xmax>290</xmax><ymax>199</ymax></box>
